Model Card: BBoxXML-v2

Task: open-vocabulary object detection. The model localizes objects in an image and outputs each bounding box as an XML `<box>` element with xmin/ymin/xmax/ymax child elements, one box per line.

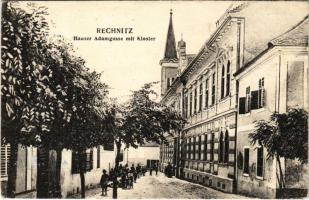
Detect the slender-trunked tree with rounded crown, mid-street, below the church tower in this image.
<box><xmin>106</xmin><ymin>83</ymin><xmax>185</xmax><ymax>198</ymax></box>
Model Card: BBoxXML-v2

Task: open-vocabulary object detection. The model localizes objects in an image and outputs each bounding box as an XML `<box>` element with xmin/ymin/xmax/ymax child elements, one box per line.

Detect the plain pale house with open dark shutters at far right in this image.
<box><xmin>235</xmin><ymin>16</ymin><xmax>309</xmax><ymax>198</ymax></box>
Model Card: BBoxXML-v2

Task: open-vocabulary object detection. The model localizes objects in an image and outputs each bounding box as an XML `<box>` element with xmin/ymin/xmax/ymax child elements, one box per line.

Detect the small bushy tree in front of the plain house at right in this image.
<box><xmin>249</xmin><ymin>108</ymin><xmax>308</xmax><ymax>188</ymax></box>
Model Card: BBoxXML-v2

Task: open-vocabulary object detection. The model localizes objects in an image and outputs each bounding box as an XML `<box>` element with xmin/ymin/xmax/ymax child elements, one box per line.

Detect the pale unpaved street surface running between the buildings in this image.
<box><xmin>86</xmin><ymin>173</ymin><xmax>247</xmax><ymax>199</ymax></box>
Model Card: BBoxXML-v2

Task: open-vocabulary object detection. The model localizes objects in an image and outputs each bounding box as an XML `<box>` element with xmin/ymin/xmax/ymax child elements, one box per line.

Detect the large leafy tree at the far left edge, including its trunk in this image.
<box><xmin>1</xmin><ymin>2</ymin><xmax>48</xmax><ymax>197</ymax></box>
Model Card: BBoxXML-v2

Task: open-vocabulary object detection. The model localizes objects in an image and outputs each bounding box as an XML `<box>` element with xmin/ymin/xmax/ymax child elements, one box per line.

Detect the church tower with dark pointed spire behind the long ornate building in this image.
<box><xmin>160</xmin><ymin>10</ymin><xmax>179</xmax><ymax>96</ymax></box>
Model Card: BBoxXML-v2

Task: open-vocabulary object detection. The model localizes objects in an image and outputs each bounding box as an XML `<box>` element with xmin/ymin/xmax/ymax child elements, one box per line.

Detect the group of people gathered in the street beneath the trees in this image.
<box><xmin>100</xmin><ymin>164</ymin><xmax>150</xmax><ymax>196</ymax></box>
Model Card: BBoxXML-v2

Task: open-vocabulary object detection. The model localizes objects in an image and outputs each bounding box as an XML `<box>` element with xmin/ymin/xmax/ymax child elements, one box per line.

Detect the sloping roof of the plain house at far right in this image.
<box><xmin>234</xmin><ymin>16</ymin><xmax>309</xmax><ymax>76</ymax></box>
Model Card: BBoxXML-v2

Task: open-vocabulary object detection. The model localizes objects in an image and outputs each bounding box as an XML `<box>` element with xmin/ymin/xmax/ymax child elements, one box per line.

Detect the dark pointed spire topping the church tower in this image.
<box><xmin>163</xmin><ymin>9</ymin><xmax>177</xmax><ymax>60</ymax></box>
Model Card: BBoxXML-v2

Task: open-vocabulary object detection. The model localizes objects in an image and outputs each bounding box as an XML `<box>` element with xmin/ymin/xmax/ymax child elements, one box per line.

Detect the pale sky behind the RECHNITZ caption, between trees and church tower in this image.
<box><xmin>19</xmin><ymin>1</ymin><xmax>230</xmax><ymax>101</ymax></box>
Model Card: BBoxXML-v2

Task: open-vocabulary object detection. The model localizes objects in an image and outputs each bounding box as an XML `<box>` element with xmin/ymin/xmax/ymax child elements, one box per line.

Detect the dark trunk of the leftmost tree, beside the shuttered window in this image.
<box><xmin>7</xmin><ymin>142</ymin><xmax>18</xmax><ymax>198</ymax></box>
